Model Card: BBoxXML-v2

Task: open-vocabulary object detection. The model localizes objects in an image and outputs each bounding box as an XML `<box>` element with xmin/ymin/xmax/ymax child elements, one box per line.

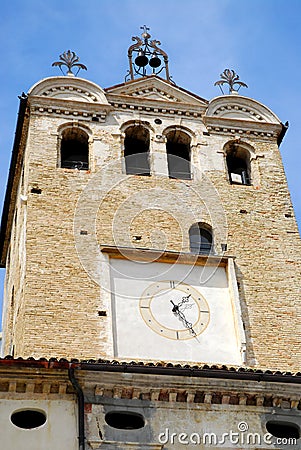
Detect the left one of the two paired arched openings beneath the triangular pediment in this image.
<box><xmin>124</xmin><ymin>125</ymin><xmax>150</xmax><ymax>175</ymax></box>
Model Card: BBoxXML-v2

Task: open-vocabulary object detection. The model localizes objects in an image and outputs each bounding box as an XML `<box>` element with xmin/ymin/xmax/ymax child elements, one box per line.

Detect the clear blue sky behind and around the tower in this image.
<box><xmin>0</xmin><ymin>0</ymin><xmax>301</xmax><ymax>326</ymax></box>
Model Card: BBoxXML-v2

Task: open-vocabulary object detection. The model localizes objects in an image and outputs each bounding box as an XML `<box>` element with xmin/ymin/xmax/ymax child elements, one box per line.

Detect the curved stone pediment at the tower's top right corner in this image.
<box><xmin>205</xmin><ymin>94</ymin><xmax>281</xmax><ymax>124</ymax></box>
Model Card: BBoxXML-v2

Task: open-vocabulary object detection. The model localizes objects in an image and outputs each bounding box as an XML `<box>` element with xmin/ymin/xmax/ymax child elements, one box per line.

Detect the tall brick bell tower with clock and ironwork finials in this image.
<box><xmin>1</xmin><ymin>26</ymin><xmax>301</xmax><ymax>449</ymax></box>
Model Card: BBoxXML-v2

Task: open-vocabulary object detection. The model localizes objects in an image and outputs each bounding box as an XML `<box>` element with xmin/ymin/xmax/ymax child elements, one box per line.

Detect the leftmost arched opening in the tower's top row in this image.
<box><xmin>60</xmin><ymin>127</ymin><xmax>89</xmax><ymax>170</ymax></box>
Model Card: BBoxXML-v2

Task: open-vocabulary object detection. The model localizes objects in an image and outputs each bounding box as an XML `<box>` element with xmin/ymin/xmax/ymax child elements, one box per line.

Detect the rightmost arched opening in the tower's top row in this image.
<box><xmin>226</xmin><ymin>143</ymin><xmax>251</xmax><ymax>185</ymax></box>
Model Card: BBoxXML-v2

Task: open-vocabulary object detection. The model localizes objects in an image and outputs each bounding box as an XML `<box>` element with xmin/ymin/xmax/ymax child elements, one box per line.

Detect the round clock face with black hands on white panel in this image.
<box><xmin>139</xmin><ymin>281</ymin><xmax>210</xmax><ymax>340</ymax></box>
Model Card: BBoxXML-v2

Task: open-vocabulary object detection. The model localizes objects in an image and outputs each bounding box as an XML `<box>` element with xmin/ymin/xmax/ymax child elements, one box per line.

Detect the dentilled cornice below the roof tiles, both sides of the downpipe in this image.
<box><xmin>0</xmin><ymin>363</ymin><xmax>301</xmax><ymax>410</ymax></box>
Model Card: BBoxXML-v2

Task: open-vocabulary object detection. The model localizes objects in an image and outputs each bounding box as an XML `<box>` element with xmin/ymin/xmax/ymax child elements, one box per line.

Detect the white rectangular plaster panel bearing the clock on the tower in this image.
<box><xmin>110</xmin><ymin>259</ymin><xmax>242</xmax><ymax>365</ymax></box>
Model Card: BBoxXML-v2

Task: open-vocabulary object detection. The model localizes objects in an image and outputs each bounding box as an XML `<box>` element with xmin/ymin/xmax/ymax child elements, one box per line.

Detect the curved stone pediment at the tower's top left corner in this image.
<box><xmin>28</xmin><ymin>76</ymin><xmax>109</xmax><ymax>104</ymax></box>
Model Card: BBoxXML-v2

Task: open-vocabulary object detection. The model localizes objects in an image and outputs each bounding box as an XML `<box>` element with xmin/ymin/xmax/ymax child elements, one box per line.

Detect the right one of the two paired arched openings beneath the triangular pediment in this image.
<box><xmin>166</xmin><ymin>129</ymin><xmax>191</xmax><ymax>180</ymax></box>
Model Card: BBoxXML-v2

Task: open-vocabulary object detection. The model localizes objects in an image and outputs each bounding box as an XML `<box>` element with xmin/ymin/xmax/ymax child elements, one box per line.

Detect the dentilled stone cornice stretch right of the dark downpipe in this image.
<box><xmin>81</xmin><ymin>372</ymin><xmax>301</xmax><ymax>409</ymax></box>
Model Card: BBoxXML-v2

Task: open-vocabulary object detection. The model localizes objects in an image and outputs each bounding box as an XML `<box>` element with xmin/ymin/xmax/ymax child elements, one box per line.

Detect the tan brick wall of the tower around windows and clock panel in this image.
<box><xmin>4</xmin><ymin>76</ymin><xmax>301</xmax><ymax>370</ymax></box>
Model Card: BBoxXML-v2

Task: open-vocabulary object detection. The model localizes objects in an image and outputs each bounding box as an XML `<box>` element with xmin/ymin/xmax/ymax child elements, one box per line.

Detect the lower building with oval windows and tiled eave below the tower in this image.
<box><xmin>0</xmin><ymin>358</ymin><xmax>301</xmax><ymax>450</ymax></box>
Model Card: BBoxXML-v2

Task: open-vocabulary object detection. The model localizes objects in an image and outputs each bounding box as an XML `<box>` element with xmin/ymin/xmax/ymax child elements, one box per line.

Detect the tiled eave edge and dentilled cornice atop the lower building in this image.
<box><xmin>0</xmin><ymin>359</ymin><xmax>301</xmax><ymax>410</ymax></box>
